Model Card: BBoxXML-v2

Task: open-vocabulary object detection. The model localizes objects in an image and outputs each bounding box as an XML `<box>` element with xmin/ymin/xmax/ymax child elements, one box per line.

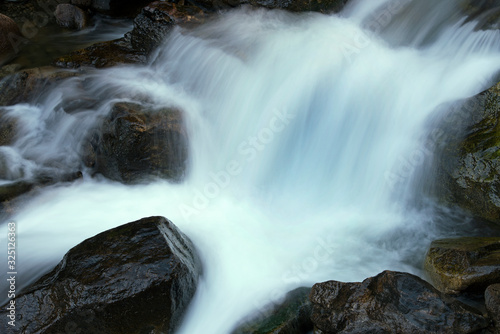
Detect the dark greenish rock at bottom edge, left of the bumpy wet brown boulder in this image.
<box><xmin>232</xmin><ymin>288</ymin><xmax>313</xmax><ymax>334</ymax></box>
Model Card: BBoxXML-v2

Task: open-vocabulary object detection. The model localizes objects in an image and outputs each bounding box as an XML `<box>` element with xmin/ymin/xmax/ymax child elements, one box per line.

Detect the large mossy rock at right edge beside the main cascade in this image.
<box><xmin>432</xmin><ymin>83</ymin><xmax>500</xmax><ymax>226</ymax></box>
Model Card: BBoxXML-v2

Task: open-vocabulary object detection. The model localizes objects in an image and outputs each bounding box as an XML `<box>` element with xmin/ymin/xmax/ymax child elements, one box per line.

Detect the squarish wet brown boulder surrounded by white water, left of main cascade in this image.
<box><xmin>85</xmin><ymin>102</ymin><xmax>187</xmax><ymax>183</ymax></box>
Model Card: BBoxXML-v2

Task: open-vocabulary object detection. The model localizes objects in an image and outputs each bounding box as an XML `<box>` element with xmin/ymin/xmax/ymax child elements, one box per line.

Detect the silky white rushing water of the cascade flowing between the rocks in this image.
<box><xmin>1</xmin><ymin>0</ymin><xmax>500</xmax><ymax>334</ymax></box>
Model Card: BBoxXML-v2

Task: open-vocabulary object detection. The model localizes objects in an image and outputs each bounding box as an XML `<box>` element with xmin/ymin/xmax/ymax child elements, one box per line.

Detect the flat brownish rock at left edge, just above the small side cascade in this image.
<box><xmin>0</xmin><ymin>66</ymin><xmax>80</xmax><ymax>106</ymax></box>
